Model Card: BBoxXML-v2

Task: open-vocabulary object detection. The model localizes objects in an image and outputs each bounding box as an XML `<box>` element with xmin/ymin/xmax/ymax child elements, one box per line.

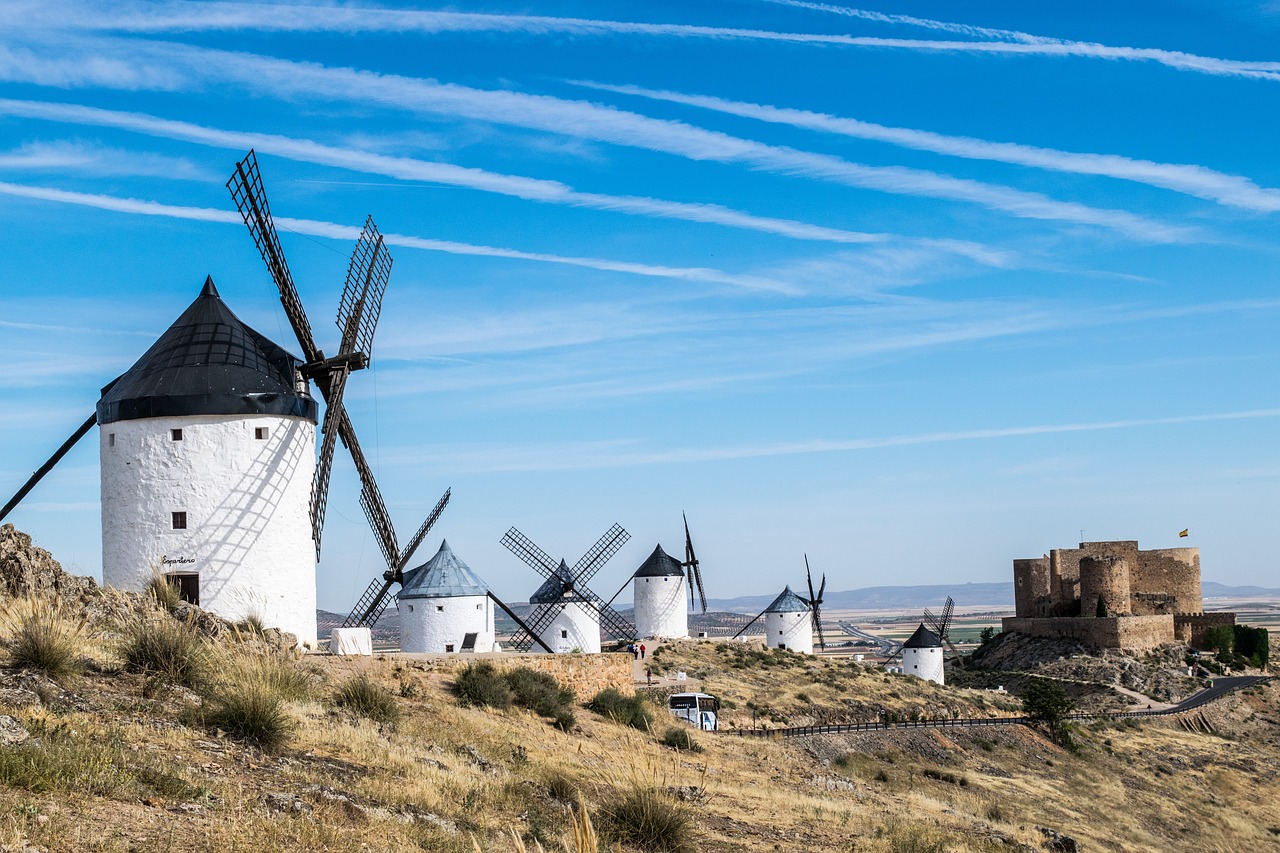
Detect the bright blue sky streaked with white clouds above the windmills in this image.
<box><xmin>0</xmin><ymin>0</ymin><xmax>1280</xmax><ymax>610</ymax></box>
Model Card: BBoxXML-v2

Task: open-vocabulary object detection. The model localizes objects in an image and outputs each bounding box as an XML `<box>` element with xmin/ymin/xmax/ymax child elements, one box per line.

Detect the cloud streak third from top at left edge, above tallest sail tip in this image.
<box><xmin>0</xmin><ymin>99</ymin><xmax>1010</xmax><ymax>256</ymax></box>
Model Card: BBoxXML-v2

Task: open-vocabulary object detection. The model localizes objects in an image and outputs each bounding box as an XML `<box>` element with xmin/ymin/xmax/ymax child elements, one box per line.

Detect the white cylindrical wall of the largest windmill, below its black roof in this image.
<box><xmin>99</xmin><ymin>415</ymin><xmax>316</xmax><ymax>647</ymax></box>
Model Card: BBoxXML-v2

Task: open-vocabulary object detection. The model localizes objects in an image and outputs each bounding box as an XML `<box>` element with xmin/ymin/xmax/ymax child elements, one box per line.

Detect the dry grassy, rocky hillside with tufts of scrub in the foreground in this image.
<box><xmin>0</xmin><ymin>522</ymin><xmax>1280</xmax><ymax>853</ymax></box>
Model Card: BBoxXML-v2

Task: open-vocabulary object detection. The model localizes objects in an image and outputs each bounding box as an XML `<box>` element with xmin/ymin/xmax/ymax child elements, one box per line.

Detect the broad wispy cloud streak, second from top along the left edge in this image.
<box><xmin>0</xmin><ymin>40</ymin><xmax>1197</xmax><ymax>242</ymax></box>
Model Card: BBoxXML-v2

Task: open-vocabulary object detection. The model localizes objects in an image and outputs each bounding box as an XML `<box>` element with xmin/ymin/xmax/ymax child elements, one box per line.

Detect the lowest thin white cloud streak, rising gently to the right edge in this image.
<box><xmin>384</xmin><ymin>409</ymin><xmax>1280</xmax><ymax>473</ymax></box>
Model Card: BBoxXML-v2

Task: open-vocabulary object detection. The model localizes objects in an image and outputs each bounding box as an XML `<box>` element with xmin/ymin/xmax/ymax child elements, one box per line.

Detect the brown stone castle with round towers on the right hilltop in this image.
<box><xmin>1004</xmin><ymin>540</ymin><xmax>1235</xmax><ymax>652</ymax></box>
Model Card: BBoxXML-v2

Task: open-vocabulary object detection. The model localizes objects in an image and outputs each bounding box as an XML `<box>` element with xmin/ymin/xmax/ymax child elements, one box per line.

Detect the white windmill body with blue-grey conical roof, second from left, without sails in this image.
<box><xmin>396</xmin><ymin>540</ymin><xmax>498</xmax><ymax>654</ymax></box>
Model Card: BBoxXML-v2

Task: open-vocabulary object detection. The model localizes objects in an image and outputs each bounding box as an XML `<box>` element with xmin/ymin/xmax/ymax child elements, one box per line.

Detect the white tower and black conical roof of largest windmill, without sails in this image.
<box><xmin>97</xmin><ymin>278</ymin><xmax>316</xmax><ymax>646</ymax></box>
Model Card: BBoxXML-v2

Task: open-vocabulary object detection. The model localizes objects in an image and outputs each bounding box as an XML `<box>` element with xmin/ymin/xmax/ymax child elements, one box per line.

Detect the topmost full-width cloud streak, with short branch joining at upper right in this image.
<box><xmin>0</xmin><ymin>0</ymin><xmax>1280</xmax><ymax>81</ymax></box>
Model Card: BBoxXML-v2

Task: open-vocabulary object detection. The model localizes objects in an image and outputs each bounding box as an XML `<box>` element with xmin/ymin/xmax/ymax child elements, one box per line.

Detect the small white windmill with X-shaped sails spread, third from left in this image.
<box><xmin>500</xmin><ymin>524</ymin><xmax>635</xmax><ymax>652</ymax></box>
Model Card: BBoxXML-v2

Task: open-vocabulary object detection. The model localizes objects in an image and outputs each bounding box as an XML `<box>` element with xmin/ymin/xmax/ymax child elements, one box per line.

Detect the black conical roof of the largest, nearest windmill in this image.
<box><xmin>97</xmin><ymin>278</ymin><xmax>316</xmax><ymax>424</ymax></box>
